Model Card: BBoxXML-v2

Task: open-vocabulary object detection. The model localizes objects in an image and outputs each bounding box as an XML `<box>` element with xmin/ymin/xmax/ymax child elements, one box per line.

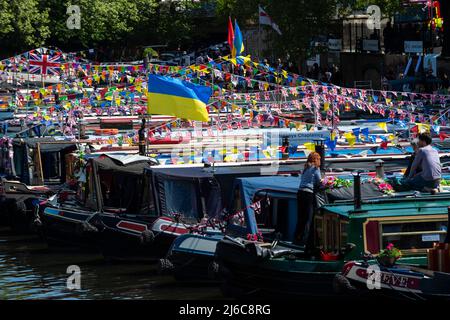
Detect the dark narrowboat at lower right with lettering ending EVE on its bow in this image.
<box><xmin>335</xmin><ymin>211</ymin><xmax>450</xmax><ymax>301</ymax></box>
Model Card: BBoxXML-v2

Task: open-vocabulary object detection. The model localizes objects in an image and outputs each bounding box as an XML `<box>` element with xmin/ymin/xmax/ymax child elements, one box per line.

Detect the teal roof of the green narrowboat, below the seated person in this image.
<box><xmin>322</xmin><ymin>193</ymin><xmax>450</xmax><ymax>218</ymax></box>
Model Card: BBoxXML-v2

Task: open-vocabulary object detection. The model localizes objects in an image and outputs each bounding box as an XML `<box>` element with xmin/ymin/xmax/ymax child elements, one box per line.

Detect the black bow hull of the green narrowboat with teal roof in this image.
<box><xmin>216</xmin><ymin>240</ymin><xmax>342</xmax><ymax>299</ymax></box>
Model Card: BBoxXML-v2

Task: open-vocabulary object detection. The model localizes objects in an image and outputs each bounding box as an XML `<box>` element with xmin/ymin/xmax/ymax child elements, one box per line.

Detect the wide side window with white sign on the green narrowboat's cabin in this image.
<box><xmin>380</xmin><ymin>220</ymin><xmax>447</xmax><ymax>253</ymax></box>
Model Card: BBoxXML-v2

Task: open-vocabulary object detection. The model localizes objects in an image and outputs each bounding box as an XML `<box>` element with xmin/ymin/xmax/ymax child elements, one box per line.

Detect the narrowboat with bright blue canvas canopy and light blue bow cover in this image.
<box><xmin>162</xmin><ymin>176</ymin><xmax>394</xmax><ymax>282</ymax></box>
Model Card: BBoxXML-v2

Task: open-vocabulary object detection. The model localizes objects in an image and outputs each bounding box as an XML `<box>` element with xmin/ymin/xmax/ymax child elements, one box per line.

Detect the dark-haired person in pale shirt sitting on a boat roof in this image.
<box><xmin>405</xmin><ymin>133</ymin><xmax>441</xmax><ymax>191</ymax></box>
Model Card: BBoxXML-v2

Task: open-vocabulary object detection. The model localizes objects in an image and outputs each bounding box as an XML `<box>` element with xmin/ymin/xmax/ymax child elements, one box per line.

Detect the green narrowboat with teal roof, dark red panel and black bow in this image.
<box><xmin>215</xmin><ymin>178</ymin><xmax>450</xmax><ymax>298</ymax></box>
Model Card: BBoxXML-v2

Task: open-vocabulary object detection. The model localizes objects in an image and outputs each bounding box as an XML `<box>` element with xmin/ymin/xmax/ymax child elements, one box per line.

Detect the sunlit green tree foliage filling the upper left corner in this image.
<box><xmin>0</xmin><ymin>0</ymin><xmax>202</xmax><ymax>55</ymax></box>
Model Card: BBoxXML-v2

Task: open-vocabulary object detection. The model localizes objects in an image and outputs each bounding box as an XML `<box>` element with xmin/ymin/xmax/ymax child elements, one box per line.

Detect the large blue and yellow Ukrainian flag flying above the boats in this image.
<box><xmin>147</xmin><ymin>74</ymin><xmax>212</xmax><ymax>122</ymax></box>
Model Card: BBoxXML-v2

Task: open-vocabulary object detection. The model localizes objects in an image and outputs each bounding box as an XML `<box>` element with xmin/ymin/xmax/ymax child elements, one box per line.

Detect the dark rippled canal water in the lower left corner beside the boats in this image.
<box><xmin>0</xmin><ymin>228</ymin><xmax>222</xmax><ymax>300</ymax></box>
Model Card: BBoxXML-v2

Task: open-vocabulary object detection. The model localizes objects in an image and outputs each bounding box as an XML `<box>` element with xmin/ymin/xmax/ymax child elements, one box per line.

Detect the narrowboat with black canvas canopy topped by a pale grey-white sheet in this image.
<box><xmin>35</xmin><ymin>154</ymin><xmax>157</xmax><ymax>250</ymax></box>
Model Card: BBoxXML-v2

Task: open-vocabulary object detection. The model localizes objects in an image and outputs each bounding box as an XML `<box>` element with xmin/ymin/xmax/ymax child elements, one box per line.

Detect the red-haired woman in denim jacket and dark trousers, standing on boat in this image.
<box><xmin>294</xmin><ymin>152</ymin><xmax>322</xmax><ymax>251</ymax></box>
